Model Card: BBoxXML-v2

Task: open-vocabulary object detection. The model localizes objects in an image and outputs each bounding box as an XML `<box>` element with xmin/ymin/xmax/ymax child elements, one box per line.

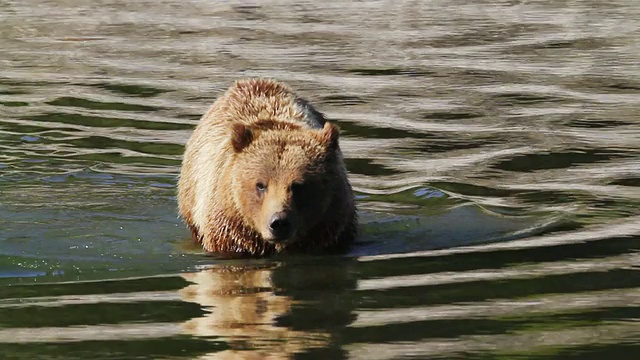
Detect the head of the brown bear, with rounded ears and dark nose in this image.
<box><xmin>230</xmin><ymin>121</ymin><xmax>342</xmax><ymax>244</ymax></box>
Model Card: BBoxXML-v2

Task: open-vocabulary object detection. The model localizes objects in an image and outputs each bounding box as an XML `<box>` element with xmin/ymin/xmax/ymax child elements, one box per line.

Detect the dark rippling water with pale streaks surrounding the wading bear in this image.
<box><xmin>0</xmin><ymin>0</ymin><xmax>640</xmax><ymax>360</ymax></box>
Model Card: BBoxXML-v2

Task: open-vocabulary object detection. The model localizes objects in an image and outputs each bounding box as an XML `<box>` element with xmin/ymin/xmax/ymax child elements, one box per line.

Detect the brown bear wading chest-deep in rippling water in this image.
<box><xmin>178</xmin><ymin>79</ymin><xmax>357</xmax><ymax>256</ymax></box>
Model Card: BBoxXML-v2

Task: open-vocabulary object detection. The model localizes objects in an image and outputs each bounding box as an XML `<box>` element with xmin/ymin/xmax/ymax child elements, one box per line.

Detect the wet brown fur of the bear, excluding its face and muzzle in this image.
<box><xmin>178</xmin><ymin>79</ymin><xmax>357</xmax><ymax>255</ymax></box>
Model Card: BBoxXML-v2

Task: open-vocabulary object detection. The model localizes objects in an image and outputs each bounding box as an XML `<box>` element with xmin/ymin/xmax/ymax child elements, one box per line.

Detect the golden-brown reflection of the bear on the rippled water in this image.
<box><xmin>180</xmin><ymin>264</ymin><xmax>356</xmax><ymax>359</ymax></box>
